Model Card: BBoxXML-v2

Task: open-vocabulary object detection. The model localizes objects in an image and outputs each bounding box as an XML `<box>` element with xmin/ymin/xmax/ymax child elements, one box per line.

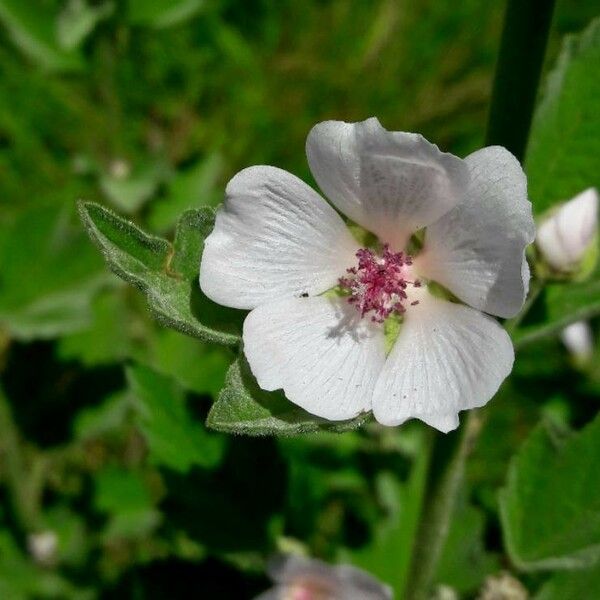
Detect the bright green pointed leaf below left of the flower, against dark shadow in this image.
<box><xmin>126</xmin><ymin>366</ymin><xmax>226</xmax><ymax>473</ymax></box>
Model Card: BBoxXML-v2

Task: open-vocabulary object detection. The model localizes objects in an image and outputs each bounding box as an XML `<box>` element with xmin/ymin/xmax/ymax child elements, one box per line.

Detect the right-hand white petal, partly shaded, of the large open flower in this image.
<box><xmin>415</xmin><ymin>146</ymin><xmax>535</xmax><ymax>317</ymax></box>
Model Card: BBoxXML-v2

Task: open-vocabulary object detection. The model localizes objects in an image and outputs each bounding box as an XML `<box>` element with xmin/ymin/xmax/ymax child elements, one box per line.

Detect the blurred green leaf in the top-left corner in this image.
<box><xmin>0</xmin><ymin>0</ymin><xmax>83</xmax><ymax>71</ymax></box>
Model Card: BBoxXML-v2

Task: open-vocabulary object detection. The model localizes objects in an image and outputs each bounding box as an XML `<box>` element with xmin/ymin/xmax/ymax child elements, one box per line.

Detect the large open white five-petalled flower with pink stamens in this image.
<box><xmin>200</xmin><ymin>118</ymin><xmax>534</xmax><ymax>431</ymax></box>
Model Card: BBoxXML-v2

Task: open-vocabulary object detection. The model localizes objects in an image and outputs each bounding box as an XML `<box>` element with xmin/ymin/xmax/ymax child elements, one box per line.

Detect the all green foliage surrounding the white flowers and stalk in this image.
<box><xmin>0</xmin><ymin>0</ymin><xmax>600</xmax><ymax>600</ymax></box>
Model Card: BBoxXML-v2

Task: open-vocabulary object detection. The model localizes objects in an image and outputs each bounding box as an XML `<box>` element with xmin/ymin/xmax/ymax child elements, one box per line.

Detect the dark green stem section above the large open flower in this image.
<box><xmin>486</xmin><ymin>0</ymin><xmax>555</xmax><ymax>161</ymax></box>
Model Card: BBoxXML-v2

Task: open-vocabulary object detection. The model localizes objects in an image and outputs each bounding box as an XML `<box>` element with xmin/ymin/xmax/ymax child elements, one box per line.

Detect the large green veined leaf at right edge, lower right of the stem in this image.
<box><xmin>500</xmin><ymin>415</ymin><xmax>600</xmax><ymax>570</ymax></box>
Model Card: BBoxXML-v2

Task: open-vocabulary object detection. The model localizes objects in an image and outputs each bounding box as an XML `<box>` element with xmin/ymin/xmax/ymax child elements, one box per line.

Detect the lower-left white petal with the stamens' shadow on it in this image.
<box><xmin>243</xmin><ymin>297</ymin><xmax>385</xmax><ymax>421</ymax></box>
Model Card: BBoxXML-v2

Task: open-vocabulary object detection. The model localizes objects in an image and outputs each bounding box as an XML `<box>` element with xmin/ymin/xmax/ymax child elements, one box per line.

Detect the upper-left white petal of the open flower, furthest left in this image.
<box><xmin>200</xmin><ymin>166</ymin><xmax>358</xmax><ymax>309</ymax></box>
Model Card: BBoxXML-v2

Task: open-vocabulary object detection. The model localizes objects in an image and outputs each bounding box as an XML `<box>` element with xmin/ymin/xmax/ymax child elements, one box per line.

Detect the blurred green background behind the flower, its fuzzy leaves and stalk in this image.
<box><xmin>0</xmin><ymin>0</ymin><xmax>600</xmax><ymax>600</ymax></box>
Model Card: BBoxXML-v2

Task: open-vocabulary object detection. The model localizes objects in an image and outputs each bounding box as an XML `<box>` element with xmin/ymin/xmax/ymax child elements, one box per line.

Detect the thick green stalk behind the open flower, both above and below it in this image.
<box><xmin>404</xmin><ymin>0</ymin><xmax>554</xmax><ymax>600</ymax></box>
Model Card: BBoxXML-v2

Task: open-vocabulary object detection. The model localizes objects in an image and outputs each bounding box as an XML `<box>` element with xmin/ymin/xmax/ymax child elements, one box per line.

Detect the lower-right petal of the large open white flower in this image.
<box><xmin>373</xmin><ymin>291</ymin><xmax>514</xmax><ymax>432</ymax></box>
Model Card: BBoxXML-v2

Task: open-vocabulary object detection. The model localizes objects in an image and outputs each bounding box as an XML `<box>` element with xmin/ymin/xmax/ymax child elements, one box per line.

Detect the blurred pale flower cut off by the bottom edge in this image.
<box><xmin>255</xmin><ymin>555</ymin><xmax>392</xmax><ymax>600</ymax></box>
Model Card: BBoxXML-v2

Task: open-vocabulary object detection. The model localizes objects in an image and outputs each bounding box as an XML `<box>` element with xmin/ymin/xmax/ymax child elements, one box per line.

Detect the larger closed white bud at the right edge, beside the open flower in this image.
<box><xmin>535</xmin><ymin>188</ymin><xmax>598</xmax><ymax>271</ymax></box>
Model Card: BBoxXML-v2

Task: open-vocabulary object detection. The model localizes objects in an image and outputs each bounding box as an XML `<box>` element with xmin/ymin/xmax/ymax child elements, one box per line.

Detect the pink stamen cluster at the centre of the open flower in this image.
<box><xmin>339</xmin><ymin>244</ymin><xmax>421</xmax><ymax>323</ymax></box>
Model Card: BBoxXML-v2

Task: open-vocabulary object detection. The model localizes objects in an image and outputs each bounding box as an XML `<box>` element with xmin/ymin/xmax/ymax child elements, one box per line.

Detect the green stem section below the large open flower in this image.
<box><xmin>404</xmin><ymin>411</ymin><xmax>482</xmax><ymax>600</ymax></box>
